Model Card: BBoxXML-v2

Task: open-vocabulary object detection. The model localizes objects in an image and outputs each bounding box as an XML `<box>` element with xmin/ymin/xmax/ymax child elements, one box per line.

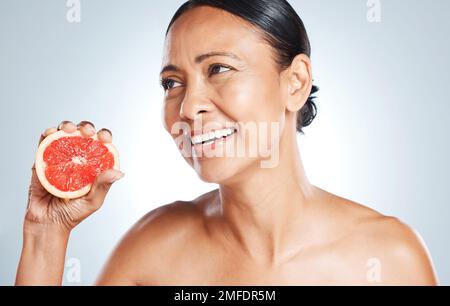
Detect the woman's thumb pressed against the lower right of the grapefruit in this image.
<box><xmin>85</xmin><ymin>170</ymin><xmax>125</xmax><ymax>208</ymax></box>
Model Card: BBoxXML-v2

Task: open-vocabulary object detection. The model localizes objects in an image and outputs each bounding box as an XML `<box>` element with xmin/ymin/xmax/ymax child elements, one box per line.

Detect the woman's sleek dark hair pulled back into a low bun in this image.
<box><xmin>166</xmin><ymin>0</ymin><xmax>319</xmax><ymax>133</ymax></box>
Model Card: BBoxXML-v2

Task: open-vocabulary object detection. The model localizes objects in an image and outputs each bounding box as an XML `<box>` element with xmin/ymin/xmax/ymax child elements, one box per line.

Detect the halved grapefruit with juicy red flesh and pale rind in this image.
<box><xmin>35</xmin><ymin>131</ymin><xmax>120</xmax><ymax>199</ymax></box>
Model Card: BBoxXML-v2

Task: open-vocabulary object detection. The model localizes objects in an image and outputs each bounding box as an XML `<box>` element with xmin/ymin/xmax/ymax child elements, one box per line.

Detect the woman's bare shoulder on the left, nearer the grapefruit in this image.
<box><xmin>97</xmin><ymin>191</ymin><xmax>214</xmax><ymax>285</ymax></box>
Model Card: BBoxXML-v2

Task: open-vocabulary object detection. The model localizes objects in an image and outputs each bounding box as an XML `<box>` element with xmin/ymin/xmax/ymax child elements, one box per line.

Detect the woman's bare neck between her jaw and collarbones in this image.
<box><xmin>220</xmin><ymin>128</ymin><xmax>314</xmax><ymax>265</ymax></box>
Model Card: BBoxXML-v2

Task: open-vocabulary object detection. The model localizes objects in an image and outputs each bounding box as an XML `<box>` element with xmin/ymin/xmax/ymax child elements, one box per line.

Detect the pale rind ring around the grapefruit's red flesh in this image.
<box><xmin>35</xmin><ymin>131</ymin><xmax>120</xmax><ymax>200</ymax></box>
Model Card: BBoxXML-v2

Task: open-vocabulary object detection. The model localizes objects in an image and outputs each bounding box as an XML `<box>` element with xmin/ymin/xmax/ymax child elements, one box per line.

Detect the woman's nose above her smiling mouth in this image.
<box><xmin>180</xmin><ymin>88</ymin><xmax>214</xmax><ymax>121</ymax></box>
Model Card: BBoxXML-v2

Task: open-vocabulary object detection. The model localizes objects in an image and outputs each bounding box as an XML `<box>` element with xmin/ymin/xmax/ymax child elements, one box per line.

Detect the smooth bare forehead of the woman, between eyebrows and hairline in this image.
<box><xmin>163</xmin><ymin>6</ymin><xmax>270</xmax><ymax>64</ymax></box>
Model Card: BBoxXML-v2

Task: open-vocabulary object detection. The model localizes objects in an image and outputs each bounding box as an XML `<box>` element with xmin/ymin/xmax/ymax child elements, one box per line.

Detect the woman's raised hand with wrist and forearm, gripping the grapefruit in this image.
<box><xmin>16</xmin><ymin>121</ymin><xmax>123</xmax><ymax>285</ymax></box>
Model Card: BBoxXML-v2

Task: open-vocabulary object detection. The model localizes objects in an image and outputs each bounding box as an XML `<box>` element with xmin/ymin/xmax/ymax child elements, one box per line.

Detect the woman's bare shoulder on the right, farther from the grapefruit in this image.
<box><xmin>328</xmin><ymin>198</ymin><xmax>437</xmax><ymax>285</ymax></box>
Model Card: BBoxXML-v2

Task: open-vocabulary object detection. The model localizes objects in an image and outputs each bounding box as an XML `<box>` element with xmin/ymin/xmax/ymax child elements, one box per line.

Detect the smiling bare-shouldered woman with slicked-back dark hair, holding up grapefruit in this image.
<box><xmin>17</xmin><ymin>0</ymin><xmax>437</xmax><ymax>285</ymax></box>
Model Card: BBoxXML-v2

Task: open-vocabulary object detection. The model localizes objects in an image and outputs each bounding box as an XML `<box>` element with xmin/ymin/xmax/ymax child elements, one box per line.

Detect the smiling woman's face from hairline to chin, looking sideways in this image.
<box><xmin>161</xmin><ymin>6</ymin><xmax>295</xmax><ymax>184</ymax></box>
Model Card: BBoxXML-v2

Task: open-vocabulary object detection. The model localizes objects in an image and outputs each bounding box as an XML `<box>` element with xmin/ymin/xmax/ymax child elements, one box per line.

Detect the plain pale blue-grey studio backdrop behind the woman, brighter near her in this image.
<box><xmin>0</xmin><ymin>0</ymin><xmax>450</xmax><ymax>285</ymax></box>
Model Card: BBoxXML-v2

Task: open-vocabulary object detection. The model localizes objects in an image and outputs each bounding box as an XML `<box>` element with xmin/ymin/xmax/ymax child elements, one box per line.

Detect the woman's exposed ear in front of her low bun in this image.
<box><xmin>284</xmin><ymin>54</ymin><xmax>313</xmax><ymax>113</ymax></box>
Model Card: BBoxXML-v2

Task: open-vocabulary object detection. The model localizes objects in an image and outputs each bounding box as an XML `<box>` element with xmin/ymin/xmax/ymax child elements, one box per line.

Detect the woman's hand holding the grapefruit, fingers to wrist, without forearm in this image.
<box><xmin>25</xmin><ymin>121</ymin><xmax>123</xmax><ymax>233</ymax></box>
